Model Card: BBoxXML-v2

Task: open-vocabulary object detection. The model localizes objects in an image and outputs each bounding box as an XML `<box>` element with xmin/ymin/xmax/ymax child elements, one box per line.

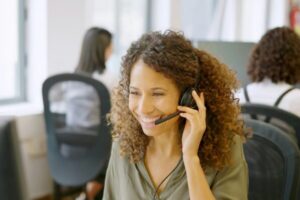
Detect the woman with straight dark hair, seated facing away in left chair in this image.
<box><xmin>63</xmin><ymin>27</ymin><xmax>116</xmax><ymax>130</ymax></box>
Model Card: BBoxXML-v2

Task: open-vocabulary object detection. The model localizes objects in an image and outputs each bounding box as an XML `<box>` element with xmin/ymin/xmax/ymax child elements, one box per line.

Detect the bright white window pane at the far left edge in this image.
<box><xmin>0</xmin><ymin>0</ymin><xmax>25</xmax><ymax>104</ymax></box>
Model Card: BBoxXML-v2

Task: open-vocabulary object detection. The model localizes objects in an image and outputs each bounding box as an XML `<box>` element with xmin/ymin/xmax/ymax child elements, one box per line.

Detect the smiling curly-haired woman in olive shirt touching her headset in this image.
<box><xmin>103</xmin><ymin>31</ymin><xmax>248</xmax><ymax>200</ymax></box>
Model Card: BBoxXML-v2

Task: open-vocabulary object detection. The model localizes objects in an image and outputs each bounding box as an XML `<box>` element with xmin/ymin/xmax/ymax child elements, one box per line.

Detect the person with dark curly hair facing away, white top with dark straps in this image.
<box><xmin>237</xmin><ymin>27</ymin><xmax>300</xmax><ymax>116</ymax></box>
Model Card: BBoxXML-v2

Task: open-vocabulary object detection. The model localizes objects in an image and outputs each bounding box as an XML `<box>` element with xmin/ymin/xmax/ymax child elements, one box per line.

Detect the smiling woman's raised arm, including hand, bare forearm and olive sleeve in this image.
<box><xmin>178</xmin><ymin>92</ymin><xmax>248</xmax><ymax>200</ymax></box>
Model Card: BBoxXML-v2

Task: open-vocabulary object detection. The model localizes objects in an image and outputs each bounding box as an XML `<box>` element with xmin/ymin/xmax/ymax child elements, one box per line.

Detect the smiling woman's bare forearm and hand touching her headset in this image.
<box><xmin>178</xmin><ymin>91</ymin><xmax>215</xmax><ymax>200</ymax></box>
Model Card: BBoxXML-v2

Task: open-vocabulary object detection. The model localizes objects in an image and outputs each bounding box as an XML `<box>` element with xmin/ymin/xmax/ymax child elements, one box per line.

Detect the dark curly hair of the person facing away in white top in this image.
<box><xmin>248</xmin><ymin>27</ymin><xmax>300</xmax><ymax>84</ymax></box>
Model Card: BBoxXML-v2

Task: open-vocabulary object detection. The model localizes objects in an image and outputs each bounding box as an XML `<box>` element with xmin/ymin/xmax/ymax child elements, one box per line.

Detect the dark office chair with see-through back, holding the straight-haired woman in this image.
<box><xmin>42</xmin><ymin>73</ymin><xmax>111</xmax><ymax>200</ymax></box>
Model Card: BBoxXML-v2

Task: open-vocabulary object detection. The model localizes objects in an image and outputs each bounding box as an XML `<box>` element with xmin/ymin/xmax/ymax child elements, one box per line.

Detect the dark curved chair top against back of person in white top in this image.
<box><xmin>241</xmin><ymin>103</ymin><xmax>300</xmax><ymax>147</ymax></box>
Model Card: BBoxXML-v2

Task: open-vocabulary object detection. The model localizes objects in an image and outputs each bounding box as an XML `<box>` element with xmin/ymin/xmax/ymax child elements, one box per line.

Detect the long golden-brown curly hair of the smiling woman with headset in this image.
<box><xmin>110</xmin><ymin>31</ymin><xmax>243</xmax><ymax>169</ymax></box>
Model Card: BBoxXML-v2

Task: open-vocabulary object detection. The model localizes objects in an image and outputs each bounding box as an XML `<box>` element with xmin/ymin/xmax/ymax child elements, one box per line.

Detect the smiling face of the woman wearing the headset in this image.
<box><xmin>129</xmin><ymin>60</ymin><xmax>180</xmax><ymax>136</ymax></box>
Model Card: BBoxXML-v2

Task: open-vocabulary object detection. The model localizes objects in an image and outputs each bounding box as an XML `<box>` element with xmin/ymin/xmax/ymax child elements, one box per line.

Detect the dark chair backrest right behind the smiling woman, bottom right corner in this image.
<box><xmin>244</xmin><ymin>119</ymin><xmax>300</xmax><ymax>200</ymax></box>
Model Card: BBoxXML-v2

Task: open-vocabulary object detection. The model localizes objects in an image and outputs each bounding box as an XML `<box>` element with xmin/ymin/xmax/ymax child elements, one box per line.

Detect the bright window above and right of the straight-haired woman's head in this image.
<box><xmin>91</xmin><ymin>0</ymin><xmax>150</xmax><ymax>55</ymax></box>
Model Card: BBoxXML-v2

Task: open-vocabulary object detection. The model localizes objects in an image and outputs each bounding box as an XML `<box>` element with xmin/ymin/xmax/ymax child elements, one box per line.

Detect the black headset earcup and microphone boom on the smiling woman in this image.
<box><xmin>154</xmin><ymin>88</ymin><xmax>197</xmax><ymax>125</ymax></box>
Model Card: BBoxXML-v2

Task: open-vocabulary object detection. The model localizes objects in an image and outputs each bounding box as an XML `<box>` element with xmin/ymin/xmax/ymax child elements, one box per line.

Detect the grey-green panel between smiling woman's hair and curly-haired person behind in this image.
<box><xmin>193</xmin><ymin>41</ymin><xmax>255</xmax><ymax>87</ymax></box>
